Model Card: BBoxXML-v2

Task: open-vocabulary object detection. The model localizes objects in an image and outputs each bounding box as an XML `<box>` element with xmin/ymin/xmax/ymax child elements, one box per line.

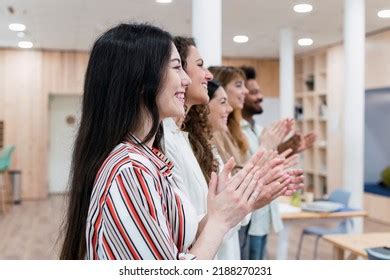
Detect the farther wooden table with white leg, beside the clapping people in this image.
<box><xmin>276</xmin><ymin>203</ymin><xmax>367</xmax><ymax>260</ymax></box>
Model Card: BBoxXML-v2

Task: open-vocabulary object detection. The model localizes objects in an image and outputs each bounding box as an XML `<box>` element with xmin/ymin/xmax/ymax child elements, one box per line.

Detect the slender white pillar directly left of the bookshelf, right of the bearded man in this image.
<box><xmin>279</xmin><ymin>28</ymin><xmax>294</xmax><ymax>118</ymax></box>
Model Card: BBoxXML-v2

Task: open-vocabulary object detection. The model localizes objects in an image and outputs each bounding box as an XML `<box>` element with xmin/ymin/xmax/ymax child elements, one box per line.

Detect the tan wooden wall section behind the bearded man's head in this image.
<box><xmin>222</xmin><ymin>57</ymin><xmax>279</xmax><ymax>97</ymax></box>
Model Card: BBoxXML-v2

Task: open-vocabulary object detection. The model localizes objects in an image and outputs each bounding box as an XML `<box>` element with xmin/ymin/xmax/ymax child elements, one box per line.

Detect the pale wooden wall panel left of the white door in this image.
<box><xmin>0</xmin><ymin>50</ymin><xmax>45</xmax><ymax>198</ymax></box>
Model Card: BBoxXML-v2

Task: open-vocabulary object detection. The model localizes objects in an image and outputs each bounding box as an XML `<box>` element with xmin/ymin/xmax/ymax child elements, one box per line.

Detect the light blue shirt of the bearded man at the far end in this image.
<box><xmin>241</xmin><ymin>119</ymin><xmax>283</xmax><ymax>236</ymax></box>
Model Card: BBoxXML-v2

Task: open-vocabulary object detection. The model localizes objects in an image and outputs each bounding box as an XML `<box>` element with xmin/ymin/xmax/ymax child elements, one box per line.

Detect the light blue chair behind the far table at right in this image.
<box><xmin>296</xmin><ymin>189</ymin><xmax>352</xmax><ymax>260</ymax></box>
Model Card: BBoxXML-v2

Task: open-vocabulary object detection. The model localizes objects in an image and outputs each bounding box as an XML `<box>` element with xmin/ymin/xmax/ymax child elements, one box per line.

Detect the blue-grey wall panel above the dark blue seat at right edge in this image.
<box><xmin>364</xmin><ymin>88</ymin><xmax>390</xmax><ymax>182</ymax></box>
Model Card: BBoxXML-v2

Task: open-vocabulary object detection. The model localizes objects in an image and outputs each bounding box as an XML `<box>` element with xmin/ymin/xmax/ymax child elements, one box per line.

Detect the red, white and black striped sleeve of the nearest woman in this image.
<box><xmin>102</xmin><ymin>167</ymin><xmax>194</xmax><ymax>260</ymax></box>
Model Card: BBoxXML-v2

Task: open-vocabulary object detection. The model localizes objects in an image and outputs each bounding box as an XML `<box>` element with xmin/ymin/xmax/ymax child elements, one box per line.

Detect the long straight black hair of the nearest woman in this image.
<box><xmin>60</xmin><ymin>24</ymin><xmax>172</xmax><ymax>259</ymax></box>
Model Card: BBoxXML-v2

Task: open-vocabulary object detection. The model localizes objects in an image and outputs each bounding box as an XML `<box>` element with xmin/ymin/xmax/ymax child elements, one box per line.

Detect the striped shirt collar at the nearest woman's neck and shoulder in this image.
<box><xmin>127</xmin><ymin>134</ymin><xmax>173</xmax><ymax>177</ymax></box>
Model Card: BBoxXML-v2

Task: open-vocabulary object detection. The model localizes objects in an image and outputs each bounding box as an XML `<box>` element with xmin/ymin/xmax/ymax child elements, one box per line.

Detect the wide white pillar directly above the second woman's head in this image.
<box><xmin>192</xmin><ymin>0</ymin><xmax>222</xmax><ymax>67</ymax></box>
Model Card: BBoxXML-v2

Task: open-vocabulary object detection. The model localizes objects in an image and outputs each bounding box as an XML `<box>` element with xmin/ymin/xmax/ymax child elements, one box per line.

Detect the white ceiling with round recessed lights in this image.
<box><xmin>0</xmin><ymin>0</ymin><xmax>390</xmax><ymax>57</ymax></box>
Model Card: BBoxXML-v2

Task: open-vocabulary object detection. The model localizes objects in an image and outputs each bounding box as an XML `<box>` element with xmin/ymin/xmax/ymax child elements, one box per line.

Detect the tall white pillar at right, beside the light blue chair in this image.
<box><xmin>343</xmin><ymin>0</ymin><xmax>365</xmax><ymax>232</ymax></box>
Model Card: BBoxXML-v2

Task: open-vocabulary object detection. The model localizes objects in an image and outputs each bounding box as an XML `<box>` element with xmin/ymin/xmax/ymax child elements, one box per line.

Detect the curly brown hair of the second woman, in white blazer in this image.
<box><xmin>173</xmin><ymin>36</ymin><xmax>218</xmax><ymax>183</ymax></box>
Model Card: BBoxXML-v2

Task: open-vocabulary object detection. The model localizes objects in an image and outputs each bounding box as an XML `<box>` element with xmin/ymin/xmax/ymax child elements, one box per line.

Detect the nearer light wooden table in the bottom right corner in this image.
<box><xmin>322</xmin><ymin>232</ymin><xmax>390</xmax><ymax>260</ymax></box>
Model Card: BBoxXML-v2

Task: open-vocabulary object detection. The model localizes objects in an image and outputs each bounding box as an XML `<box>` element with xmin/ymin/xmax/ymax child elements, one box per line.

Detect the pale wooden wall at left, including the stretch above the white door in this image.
<box><xmin>0</xmin><ymin>49</ymin><xmax>89</xmax><ymax>199</ymax></box>
